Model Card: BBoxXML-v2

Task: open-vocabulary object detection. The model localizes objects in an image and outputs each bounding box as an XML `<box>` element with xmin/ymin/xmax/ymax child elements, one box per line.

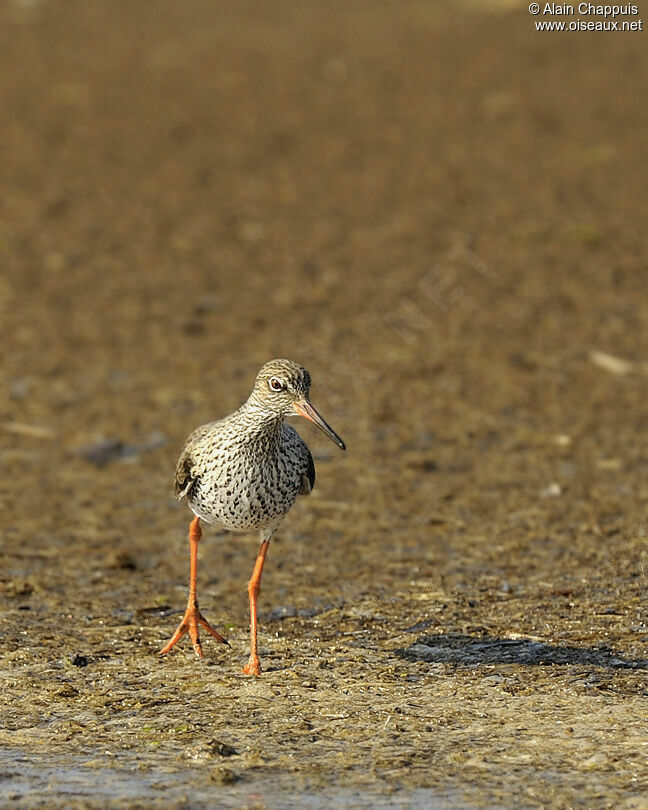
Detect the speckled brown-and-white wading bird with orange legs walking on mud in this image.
<box><xmin>159</xmin><ymin>359</ymin><xmax>346</xmax><ymax>675</ymax></box>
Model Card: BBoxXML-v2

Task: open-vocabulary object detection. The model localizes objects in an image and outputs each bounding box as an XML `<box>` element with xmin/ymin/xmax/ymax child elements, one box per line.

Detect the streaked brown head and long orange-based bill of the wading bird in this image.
<box><xmin>252</xmin><ymin>360</ymin><xmax>345</xmax><ymax>450</ymax></box>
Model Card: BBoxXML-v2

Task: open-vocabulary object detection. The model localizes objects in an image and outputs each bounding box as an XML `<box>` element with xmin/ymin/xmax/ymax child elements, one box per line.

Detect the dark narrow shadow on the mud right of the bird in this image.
<box><xmin>394</xmin><ymin>633</ymin><xmax>648</xmax><ymax>670</ymax></box>
